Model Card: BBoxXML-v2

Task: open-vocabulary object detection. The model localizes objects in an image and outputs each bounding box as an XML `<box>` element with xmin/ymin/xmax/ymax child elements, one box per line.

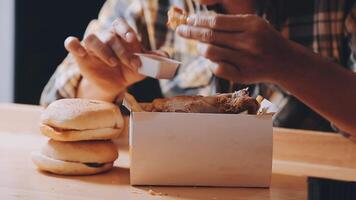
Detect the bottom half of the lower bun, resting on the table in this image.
<box><xmin>32</xmin><ymin>152</ymin><xmax>113</xmax><ymax>175</ymax></box>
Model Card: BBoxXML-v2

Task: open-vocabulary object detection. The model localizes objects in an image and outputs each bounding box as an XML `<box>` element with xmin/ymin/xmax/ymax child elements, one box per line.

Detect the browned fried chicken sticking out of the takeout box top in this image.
<box><xmin>143</xmin><ymin>89</ymin><xmax>260</xmax><ymax>114</ymax></box>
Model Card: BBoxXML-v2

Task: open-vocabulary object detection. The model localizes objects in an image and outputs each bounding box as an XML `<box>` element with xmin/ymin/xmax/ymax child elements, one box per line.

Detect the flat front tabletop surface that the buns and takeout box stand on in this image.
<box><xmin>0</xmin><ymin>132</ymin><xmax>307</xmax><ymax>200</ymax></box>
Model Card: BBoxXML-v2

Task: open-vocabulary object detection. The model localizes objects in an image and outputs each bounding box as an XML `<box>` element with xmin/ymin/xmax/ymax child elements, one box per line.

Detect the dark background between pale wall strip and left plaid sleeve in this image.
<box><xmin>15</xmin><ymin>0</ymin><xmax>105</xmax><ymax>104</ymax></box>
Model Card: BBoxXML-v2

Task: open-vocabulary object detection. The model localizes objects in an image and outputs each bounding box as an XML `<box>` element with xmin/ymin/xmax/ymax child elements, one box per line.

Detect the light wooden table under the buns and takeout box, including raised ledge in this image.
<box><xmin>0</xmin><ymin>104</ymin><xmax>356</xmax><ymax>200</ymax></box>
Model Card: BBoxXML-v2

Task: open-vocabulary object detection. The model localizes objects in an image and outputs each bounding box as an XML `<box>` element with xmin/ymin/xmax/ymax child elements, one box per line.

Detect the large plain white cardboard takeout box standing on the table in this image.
<box><xmin>124</xmin><ymin>97</ymin><xmax>272</xmax><ymax>187</ymax></box>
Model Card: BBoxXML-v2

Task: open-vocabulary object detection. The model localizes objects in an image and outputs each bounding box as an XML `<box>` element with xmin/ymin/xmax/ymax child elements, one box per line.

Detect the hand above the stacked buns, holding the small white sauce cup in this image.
<box><xmin>65</xmin><ymin>20</ymin><xmax>145</xmax><ymax>101</ymax></box>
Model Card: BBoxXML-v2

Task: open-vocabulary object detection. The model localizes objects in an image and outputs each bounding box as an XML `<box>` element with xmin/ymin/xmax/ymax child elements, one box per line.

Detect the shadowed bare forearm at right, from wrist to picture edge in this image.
<box><xmin>277</xmin><ymin>44</ymin><xmax>356</xmax><ymax>136</ymax></box>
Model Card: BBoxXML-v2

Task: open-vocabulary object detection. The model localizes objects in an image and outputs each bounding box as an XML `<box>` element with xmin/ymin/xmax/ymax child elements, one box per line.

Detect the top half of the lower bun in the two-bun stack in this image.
<box><xmin>41</xmin><ymin>140</ymin><xmax>118</xmax><ymax>163</ymax></box>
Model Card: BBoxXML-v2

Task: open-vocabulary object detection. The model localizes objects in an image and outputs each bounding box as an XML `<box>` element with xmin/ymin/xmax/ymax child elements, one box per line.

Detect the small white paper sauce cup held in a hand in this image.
<box><xmin>135</xmin><ymin>53</ymin><xmax>180</xmax><ymax>79</ymax></box>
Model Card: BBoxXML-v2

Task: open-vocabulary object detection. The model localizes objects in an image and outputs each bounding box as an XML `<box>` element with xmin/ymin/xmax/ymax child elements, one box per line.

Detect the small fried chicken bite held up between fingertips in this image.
<box><xmin>167</xmin><ymin>6</ymin><xmax>188</xmax><ymax>30</ymax></box>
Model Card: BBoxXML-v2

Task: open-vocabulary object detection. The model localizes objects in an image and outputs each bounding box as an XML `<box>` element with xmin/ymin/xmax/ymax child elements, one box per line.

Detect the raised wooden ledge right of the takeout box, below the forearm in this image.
<box><xmin>273</xmin><ymin>128</ymin><xmax>356</xmax><ymax>181</ymax></box>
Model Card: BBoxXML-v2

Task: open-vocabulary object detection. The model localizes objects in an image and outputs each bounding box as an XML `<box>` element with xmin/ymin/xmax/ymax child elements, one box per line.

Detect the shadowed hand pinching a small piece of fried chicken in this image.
<box><xmin>177</xmin><ymin>15</ymin><xmax>296</xmax><ymax>83</ymax></box>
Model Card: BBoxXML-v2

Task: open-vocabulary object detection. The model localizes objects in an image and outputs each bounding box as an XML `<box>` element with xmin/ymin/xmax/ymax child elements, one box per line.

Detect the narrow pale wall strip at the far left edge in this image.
<box><xmin>0</xmin><ymin>0</ymin><xmax>15</xmax><ymax>102</ymax></box>
